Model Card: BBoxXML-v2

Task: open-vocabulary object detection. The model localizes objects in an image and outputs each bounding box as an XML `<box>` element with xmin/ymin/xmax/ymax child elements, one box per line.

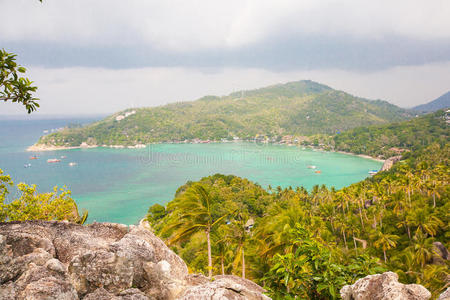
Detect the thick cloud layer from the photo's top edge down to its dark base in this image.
<box><xmin>0</xmin><ymin>0</ymin><xmax>450</xmax><ymax>70</ymax></box>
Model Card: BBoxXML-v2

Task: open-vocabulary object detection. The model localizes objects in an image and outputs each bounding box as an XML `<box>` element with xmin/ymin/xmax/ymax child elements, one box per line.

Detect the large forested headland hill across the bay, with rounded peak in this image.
<box><xmin>38</xmin><ymin>81</ymin><xmax>411</xmax><ymax>146</ymax></box>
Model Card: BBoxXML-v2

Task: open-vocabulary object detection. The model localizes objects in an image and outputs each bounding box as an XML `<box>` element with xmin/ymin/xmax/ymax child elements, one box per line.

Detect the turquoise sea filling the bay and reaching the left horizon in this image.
<box><xmin>0</xmin><ymin>118</ymin><xmax>382</xmax><ymax>224</ymax></box>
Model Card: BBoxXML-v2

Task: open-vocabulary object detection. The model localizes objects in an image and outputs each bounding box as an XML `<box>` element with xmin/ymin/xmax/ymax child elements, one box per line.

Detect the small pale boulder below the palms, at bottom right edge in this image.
<box><xmin>341</xmin><ymin>272</ymin><xmax>431</xmax><ymax>300</ymax></box>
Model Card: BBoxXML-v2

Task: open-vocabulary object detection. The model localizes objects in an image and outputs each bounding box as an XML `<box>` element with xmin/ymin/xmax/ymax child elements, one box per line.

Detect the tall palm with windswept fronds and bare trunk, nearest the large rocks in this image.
<box><xmin>164</xmin><ymin>183</ymin><xmax>227</xmax><ymax>278</ymax></box>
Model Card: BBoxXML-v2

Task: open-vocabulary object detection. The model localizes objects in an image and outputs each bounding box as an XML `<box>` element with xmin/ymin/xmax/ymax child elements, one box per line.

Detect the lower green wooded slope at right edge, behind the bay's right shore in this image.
<box><xmin>334</xmin><ymin>110</ymin><xmax>450</xmax><ymax>158</ymax></box>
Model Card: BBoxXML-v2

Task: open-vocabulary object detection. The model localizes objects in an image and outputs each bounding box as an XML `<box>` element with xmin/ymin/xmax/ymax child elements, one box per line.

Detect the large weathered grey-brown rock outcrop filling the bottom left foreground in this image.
<box><xmin>0</xmin><ymin>221</ymin><xmax>269</xmax><ymax>300</ymax></box>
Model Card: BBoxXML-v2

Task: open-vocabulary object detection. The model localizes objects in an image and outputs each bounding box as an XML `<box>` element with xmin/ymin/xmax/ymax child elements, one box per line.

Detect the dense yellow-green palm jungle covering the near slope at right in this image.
<box><xmin>148</xmin><ymin>143</ymin><xmax>450</xmax><ymax>299</ymax></box>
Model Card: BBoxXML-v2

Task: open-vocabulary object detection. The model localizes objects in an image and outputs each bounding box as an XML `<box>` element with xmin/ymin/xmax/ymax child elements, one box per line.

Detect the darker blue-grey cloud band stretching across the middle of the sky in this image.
<box><xmin>5</xmin><ymin>36</ymin><xmax>450</xmax><ymax>71</ymax></box>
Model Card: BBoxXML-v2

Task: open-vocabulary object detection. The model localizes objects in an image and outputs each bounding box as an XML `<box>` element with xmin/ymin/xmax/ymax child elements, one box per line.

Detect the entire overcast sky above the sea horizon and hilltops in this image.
<box><xmin>0</xmin><ymin>0</ymin><xmax>450</xmax><ymax>114</ymax></box>
